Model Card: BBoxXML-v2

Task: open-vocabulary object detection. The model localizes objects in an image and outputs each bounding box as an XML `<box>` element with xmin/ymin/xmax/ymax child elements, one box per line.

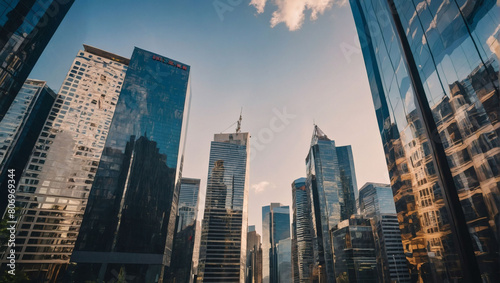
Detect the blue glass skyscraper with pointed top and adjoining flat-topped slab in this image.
<box><xmin>306</xmin><ymin>125</ymin><xmax>357</xmax><ymax>282</ymax></box>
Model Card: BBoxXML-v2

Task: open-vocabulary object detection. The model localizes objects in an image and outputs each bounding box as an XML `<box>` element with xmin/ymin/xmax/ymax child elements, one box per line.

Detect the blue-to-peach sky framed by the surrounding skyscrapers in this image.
<box><xmin>30</xmin><ymin>0</ymin><xmax>389</xmax><ymax>233</ymax></box>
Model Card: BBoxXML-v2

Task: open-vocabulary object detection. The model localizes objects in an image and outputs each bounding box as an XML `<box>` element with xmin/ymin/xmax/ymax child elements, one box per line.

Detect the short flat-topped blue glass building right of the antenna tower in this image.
<box><xmin>262</xmin><ymin>203</ymin><xmax>291</xmax><ymax>282</ymax></box>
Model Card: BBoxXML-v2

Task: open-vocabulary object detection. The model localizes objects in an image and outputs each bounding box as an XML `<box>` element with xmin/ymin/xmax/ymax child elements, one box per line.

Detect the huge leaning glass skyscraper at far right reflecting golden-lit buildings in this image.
<box><xmin>350</xmin><ymin>0</ymin><xmax>500</xmax><ymax>282</ymax></box>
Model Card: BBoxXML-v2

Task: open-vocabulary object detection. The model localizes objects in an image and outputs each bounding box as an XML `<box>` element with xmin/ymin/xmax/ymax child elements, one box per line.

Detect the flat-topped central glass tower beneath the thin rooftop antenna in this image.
<box><xmin>197</xmin><ymin>132</ymin><xmax>250</xmax><ymax>282</ymax></box>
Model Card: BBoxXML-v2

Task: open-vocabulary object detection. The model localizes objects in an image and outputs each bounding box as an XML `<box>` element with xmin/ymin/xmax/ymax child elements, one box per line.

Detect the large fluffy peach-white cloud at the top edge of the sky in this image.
<box><xmin>249</xmin><ymin>0</ymin><xmax>347</xmax><ymax>31</ymax></box>
